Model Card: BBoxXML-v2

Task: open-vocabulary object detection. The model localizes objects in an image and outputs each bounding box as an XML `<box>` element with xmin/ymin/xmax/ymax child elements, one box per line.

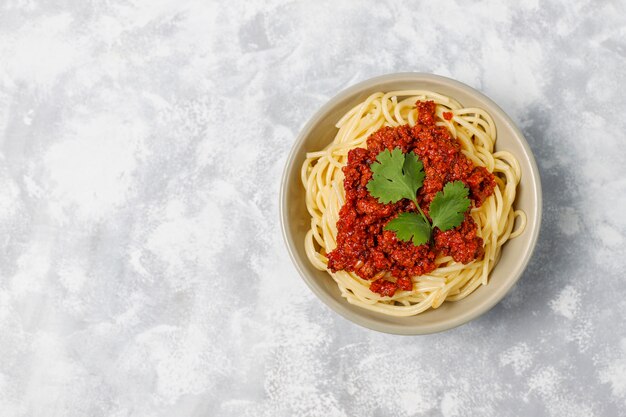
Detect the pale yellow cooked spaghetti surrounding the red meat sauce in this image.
<box><xmin>301</xmin><ymin>90</ymin><xmax>526</xmax><ymax>316</ymax></box>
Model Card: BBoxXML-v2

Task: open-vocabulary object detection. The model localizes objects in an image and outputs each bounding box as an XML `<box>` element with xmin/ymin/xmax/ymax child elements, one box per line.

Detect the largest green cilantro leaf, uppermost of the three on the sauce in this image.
<box><xmin>367</xmin><ymin>148</ymin><xmax>424</xmax><ymax>204</ymax></box>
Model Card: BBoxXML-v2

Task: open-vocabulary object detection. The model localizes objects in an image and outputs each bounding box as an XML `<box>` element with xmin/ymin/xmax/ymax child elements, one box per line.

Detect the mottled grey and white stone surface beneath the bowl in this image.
<box><xmin>0</xmin><ymin>0</ymin><xmax>626</xmax><ymax>417</ymax></box>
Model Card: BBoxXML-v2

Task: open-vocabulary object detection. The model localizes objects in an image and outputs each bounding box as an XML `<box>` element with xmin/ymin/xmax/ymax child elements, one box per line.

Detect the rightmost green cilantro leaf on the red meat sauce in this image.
<box><xmin>428</xmin><ymin>181</ymin><xmax>470</xmax><ymax>231</ymax></box>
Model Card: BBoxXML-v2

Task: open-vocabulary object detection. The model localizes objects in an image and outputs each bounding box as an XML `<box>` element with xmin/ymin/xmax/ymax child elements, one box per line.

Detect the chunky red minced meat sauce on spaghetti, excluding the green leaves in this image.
<box><xmin>328</xmin><ymin>101</ymin><xmax>495</xmax><ymax>296</ymax></box>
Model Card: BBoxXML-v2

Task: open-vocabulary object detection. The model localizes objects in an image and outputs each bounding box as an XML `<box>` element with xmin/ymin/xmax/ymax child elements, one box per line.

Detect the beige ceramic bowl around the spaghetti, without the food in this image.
<box><xmin>280</xmin><ymin>73</ymin><xmax>541</xmax><ymax>335</ymax></box>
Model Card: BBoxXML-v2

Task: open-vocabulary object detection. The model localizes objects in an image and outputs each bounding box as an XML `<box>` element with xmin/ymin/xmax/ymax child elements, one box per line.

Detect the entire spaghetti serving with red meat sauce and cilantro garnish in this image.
<box><xmin>301</xmin><ymin>90</ymin><xmax>526</xmax><ymax>316</ymax></box>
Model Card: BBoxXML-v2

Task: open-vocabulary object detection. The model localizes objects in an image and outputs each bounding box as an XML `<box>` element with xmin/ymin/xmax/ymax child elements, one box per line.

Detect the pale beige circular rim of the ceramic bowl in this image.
<box><xmin>279</xmin><ymin>72</ymin><xmax>543</xmax><ymax>335</ymax></box>
